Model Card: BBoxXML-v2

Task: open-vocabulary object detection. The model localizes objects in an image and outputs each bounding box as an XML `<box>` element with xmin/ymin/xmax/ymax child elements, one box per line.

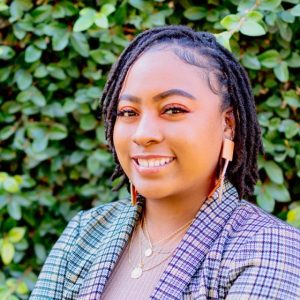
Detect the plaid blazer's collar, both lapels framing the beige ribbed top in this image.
<box><xmin>77</xmin><ymin>181</ymin><xmax>238</xmax><ymax>300</ymax></box>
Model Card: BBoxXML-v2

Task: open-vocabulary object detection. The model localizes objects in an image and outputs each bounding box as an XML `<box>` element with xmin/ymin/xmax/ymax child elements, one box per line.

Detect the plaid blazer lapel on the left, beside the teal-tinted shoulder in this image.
<box><xmin>77</xmin><ymin>201</ymin><xmax>143</xmax><ymax>300</ymax></box>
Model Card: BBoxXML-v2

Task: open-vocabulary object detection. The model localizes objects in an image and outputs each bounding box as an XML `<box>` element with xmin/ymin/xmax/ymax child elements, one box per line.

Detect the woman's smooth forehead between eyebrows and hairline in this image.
<box><xmin>120</xmin><ymin>50</ymin><xmax>213</xmax><ymax>95</ymax></box>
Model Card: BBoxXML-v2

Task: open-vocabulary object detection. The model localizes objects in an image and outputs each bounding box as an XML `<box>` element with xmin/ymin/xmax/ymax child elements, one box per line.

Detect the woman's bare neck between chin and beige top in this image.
<box><xmin>144</xmin><ymin>179</ymin><xmax>212</xmax><ymax>243</ymax></box>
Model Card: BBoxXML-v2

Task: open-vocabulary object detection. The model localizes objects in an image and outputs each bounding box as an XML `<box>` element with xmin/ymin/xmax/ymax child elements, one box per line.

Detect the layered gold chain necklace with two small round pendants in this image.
<box><xmin>128</xmin><ymin>218</ymin><xmax>193</xmax><ymax>279</ymax></box>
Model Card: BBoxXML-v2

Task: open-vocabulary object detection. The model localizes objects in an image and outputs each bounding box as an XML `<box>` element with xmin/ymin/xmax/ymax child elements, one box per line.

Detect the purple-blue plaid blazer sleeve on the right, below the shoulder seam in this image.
<box><xmin>226</xmin><ymin>226</ymin><xmax>300</xmax><ymax>300</ymax></box>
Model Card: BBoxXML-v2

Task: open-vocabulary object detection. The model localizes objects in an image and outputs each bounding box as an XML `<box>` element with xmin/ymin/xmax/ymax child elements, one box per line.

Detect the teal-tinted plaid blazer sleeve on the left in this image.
<box><xmin>29</xmin><ymin>211</ymin><xmax>82</xmax><ymax>300</ymax></box>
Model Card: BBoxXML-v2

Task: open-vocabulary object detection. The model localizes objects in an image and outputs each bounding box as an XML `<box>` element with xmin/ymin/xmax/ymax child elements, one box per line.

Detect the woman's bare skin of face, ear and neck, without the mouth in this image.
<box><xmin>113</xmin><ymin>49</ymin><xmax>234</xmax><ymax>242</ymax></box>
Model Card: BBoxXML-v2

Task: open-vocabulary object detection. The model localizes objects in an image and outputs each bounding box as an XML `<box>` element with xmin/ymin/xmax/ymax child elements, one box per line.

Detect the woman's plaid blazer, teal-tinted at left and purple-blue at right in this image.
<box><xmin>30</xmin><ymin>182</ymin><xmax>300</xmax><ymax>300</ymax></box>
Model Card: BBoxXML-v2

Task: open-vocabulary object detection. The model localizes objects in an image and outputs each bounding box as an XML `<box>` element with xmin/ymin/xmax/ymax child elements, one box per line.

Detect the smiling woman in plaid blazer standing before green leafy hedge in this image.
<box><xmin>31</xmin><ymin>26</ymin><xmax>300</xmax><ymax>300</ymax></box>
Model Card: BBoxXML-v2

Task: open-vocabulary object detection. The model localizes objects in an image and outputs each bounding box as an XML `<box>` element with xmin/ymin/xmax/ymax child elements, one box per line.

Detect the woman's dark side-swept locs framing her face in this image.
<box><xmin>98</xmin><ymin>25</ymin><xmax>263</xmax><ymax>198</ymax></box>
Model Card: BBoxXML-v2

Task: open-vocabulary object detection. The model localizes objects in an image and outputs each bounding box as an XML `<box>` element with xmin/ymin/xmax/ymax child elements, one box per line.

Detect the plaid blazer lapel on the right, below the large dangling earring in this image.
<box><xmin>150</xmin><ymin>181</ymin><xmax>238</xmax><ymax>300</ymax></box>
